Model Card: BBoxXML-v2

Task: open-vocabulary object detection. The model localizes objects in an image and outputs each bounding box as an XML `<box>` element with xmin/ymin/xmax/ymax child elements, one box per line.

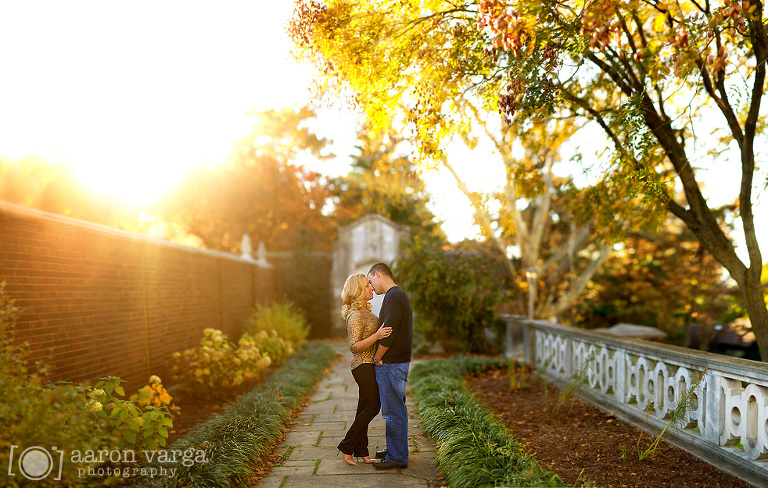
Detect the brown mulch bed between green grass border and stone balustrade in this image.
<box><xmin>468</xmin><ymin>371</ymin><xmax>751</xmax><ymax>488</ymax></box>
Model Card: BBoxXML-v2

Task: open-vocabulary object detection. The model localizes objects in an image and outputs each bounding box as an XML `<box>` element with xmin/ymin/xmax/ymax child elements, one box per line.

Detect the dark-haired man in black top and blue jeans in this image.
<box><xmin>368</xmin><ymin>263</ymin><xmax>413</xmax><ymax>469</ymax></box>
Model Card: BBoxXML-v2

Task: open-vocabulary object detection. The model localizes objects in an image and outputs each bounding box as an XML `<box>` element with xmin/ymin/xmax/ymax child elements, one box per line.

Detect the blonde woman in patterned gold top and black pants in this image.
<box><xmin>339</xmin><ymin>273</ymin><xmax>392</xmax><ymax>466</ymax></box>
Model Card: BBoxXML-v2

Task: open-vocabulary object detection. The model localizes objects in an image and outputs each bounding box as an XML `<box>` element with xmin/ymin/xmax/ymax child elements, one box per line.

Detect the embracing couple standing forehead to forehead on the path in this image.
<box><xmin>338</xmin><ymin>263</ymin><xmax>413</xmax><ymax>469</ymax></box>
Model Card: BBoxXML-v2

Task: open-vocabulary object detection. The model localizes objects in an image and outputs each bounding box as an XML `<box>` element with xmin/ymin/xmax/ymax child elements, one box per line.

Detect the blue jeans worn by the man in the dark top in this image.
<box><xmin>376</xmin><ymin>363</ymin><xmax>411</xmax><ymax>465</ymax></box>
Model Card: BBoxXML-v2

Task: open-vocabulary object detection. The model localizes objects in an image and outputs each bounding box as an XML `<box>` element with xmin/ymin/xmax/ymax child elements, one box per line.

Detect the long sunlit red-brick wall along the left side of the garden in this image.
<box><xmin>0</xmin><ymin>203</ymin><xmax>274</xmax><ymax>390</ymax></box>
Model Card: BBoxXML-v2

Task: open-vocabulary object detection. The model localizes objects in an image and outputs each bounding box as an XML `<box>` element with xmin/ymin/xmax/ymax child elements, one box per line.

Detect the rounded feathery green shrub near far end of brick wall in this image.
<box><xmin>245</xmin><ymin>302</ymin><xmax>309</xmax><ymax>349</ymax></box>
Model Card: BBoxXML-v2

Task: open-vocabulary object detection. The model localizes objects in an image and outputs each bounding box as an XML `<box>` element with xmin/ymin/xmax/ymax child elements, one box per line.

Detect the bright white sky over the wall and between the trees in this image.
<box><xmin>0</xmin><ymin>0</ymin><xmax>768</xmax><ymax>252</ymax></box>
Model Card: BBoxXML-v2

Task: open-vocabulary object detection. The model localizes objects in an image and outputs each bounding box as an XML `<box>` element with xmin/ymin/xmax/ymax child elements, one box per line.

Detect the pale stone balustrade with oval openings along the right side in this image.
<box><xmin>521</xmin><ymin>321</ymin><xmax>768</xmax><ymax>486</ymax></box>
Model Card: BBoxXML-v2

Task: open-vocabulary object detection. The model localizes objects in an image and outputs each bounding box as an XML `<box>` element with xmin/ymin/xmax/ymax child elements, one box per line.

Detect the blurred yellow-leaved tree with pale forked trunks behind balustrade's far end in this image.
<box><xmin>443</xmin><ymin>116</ymin><xmax>611</xmax><ymax>320</ymax></box>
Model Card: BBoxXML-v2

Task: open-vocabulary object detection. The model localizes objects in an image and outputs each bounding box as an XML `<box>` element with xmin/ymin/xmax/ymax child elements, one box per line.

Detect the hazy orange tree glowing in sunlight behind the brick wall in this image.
<box><xmin>162</xmin><ymin>108</ymin><xmax>334</xmax><ymax>252</ymax></box>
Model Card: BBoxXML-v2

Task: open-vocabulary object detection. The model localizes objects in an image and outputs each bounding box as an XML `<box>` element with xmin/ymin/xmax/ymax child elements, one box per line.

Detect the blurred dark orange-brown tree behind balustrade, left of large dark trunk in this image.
<box><xmin>574</xmin><ymin>219</ymin><xmax>743</xmax><ymax>347</ymax></box>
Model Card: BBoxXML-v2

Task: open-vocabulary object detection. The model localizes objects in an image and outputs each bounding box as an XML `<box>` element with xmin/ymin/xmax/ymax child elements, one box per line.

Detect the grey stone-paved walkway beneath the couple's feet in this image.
<box><xmin>254</xmin><ymin>342</ymin><xmax>440</xmax><ymax>488</ymax></box>
